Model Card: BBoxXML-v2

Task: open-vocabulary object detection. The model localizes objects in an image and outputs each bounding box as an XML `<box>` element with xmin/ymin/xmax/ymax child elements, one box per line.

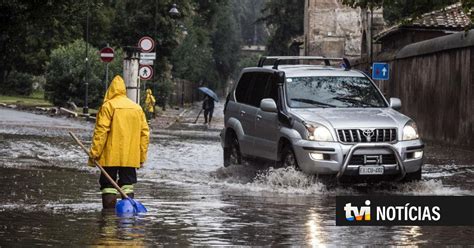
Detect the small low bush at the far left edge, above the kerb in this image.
<box><xmin>1</xmin><ymin>71</ymin><xmax>33</xmax><ymax>96</ymax></box>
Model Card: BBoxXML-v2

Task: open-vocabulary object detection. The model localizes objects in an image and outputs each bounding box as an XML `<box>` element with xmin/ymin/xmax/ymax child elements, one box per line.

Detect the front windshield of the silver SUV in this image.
<box><xmin>285</xmin><ymin>77</ymin><xmax>387</xmax><ymax>108</ymax></box>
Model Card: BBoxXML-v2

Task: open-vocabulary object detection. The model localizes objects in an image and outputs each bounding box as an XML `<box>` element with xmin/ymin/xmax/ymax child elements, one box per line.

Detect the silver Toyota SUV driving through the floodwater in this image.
<box><xmin>221</xmin><ymin>57</ymin><xmax>424</xmax><ymax>180</ymax></box>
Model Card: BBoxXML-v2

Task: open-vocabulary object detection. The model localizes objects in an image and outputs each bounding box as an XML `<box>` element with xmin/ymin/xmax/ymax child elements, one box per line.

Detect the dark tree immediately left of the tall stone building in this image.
<box><xmin>260</xmin><ymin>0</ymin><xmax>305</xmax><ymax>55</ymax></box>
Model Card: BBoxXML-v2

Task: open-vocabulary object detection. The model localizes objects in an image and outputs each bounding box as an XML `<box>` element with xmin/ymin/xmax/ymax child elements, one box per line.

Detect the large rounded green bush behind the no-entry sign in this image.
<box><xmin>45</xmin><ymin>40</ymin><xmax>122</xmax><ymax>108</ymax></box>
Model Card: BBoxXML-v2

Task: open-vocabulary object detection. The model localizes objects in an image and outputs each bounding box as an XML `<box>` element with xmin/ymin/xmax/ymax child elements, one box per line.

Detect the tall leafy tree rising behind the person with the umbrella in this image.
<box><xmin>172</xmin><ymin>1</ymin><xmax>241</xmax><ymax>89</ymax></box>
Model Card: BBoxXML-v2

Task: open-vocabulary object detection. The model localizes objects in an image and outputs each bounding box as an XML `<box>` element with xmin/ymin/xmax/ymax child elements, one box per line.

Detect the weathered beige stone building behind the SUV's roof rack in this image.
<box><xmin>304</xmin><ymin>0</ymin><xmax>384</xmax><ymax>58</ymax></box>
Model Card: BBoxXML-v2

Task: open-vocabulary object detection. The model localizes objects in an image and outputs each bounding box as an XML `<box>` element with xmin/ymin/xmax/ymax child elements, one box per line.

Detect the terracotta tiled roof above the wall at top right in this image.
<box><xmin>375</xmin><ymin>2</ymin><xmax>474</xmax><ymax>40</ymax></box>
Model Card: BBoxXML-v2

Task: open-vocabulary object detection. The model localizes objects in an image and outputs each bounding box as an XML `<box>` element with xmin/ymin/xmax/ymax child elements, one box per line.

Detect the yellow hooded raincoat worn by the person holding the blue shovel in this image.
<box><xmin>90</xmin><ymin>76</ymin><xmax>150</xmax><ymax>168</ymax></box>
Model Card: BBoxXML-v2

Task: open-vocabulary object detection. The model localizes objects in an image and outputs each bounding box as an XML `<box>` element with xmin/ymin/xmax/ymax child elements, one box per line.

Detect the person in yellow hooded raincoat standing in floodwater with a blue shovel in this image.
<box><xmin>89</xmin><ymin>76</ymin><xmax>150</xmax><ymax>209</ymax></box>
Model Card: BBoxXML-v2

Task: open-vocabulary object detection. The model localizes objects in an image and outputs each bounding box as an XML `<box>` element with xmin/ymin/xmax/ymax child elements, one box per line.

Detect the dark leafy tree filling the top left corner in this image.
<box><xmin>0</xmin><ymin>0</ymin><xmax>101</xmax><ymax>94</ymax></box>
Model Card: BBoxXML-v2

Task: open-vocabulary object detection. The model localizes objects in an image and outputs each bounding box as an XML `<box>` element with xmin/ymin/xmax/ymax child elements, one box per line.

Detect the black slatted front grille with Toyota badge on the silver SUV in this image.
<box><xmin>337</xmin><ymin>128</ymin><xmax>397</xmax><ymax>143</ymax></box>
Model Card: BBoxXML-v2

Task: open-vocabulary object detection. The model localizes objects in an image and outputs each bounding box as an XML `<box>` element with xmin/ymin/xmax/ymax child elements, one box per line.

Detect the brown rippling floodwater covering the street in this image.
<box><xmin>0</xmin><ymin>108</ymin><xmax>474</xmax><ymax>246</ymax></box>
